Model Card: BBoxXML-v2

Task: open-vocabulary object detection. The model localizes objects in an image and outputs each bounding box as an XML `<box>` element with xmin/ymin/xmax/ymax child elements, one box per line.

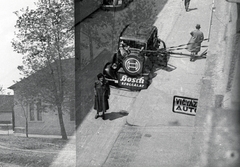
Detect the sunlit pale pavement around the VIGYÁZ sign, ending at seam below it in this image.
<box><xmin>127</xmin><ymin>0</ymin><xmax>211</xmax><ymax>126</ymax></box>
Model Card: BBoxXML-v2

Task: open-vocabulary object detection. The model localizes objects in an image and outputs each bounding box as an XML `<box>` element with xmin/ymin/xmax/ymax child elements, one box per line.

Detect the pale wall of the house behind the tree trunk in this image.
<box><xmin>14</xmin><ymin>94</ymin><xmax>75</xmax><ymax>136</ymax></box>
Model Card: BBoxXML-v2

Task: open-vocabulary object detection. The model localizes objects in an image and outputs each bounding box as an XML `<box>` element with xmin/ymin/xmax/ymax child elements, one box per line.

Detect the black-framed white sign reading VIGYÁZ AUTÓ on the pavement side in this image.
<box><xmin>172</xmin><ymin>96</ymin><xmax>198</xmax><ymax>116</ymax></box>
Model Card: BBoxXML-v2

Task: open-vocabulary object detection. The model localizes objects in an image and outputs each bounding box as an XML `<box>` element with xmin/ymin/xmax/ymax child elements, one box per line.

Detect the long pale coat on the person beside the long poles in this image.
<box><xmin>187</xmin><ymin>29</ymin><xmax>204</xmax><ymax>52</ymax></box>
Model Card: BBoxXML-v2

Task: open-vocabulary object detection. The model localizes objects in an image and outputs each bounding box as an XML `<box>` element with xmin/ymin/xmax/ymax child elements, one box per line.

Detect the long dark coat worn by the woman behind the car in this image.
<box><xmin>94</xmin><ymin>80</ymin><xmax>110</xmax><ymax>112</ymax></box>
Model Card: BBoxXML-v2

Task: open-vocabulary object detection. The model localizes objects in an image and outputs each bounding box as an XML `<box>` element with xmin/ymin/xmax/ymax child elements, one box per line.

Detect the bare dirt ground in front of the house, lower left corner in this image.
<box><xmin>0</xmin><ymin>135</ymin><xmax>75</xmax><ymax>167</ymax></box>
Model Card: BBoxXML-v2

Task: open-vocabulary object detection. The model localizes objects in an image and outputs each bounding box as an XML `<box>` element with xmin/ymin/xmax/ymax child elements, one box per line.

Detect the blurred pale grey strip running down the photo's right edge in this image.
<box><xmin>190</xmin><ymin>1</ymin><xmax>240</xmax><ymax>167</ymax></box>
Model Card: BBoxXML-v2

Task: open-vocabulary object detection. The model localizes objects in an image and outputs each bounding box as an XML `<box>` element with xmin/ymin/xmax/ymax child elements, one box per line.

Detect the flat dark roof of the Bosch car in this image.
<box><xmin>120</xmin><ymin>25</ymin><xmax>157</xmax><ymax>43</ymax></box>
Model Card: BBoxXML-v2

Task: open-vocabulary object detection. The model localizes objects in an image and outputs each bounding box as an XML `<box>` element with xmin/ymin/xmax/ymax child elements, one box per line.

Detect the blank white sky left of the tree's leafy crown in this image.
<box><xmin>0</xmin><ymin>0</ymin><xmax>38</xmax><ymax>94</ymax></box>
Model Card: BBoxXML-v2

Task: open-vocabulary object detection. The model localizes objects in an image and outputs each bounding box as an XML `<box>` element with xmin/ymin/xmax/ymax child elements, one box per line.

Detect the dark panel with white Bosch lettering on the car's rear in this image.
<box><xmin>118</xmin><ymin>73</ymin><xmax>148</xmax><ymax>90</ymax></box>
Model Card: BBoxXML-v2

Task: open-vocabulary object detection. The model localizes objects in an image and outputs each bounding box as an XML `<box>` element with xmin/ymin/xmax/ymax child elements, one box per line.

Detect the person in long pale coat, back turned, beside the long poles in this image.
<box><xmin>187</xmin><ymin>24</ymin><xmax>204</xmax><ymax>61</ymax></box>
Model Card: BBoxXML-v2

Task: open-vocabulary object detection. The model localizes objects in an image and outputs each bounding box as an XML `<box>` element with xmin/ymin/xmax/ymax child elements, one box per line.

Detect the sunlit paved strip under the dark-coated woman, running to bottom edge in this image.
<box><xmin>76</xmin><ymin>89</ymin><xmax>138</xmax><ymax>167</ymax></box>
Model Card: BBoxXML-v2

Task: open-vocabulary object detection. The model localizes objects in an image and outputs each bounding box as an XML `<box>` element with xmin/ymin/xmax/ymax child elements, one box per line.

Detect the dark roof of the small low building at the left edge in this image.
<box><xmin>0</xmin><ymin>95</ymin><xmax>14</xmax><ymax>112</ymax></box>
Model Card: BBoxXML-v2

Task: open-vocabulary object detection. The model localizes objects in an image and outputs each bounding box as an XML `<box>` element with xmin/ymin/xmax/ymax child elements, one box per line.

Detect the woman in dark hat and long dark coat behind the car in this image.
<box><xmin>94</xmin><ymin>73</ymin><xmax>110</xmax><ymax>119</ymax></box>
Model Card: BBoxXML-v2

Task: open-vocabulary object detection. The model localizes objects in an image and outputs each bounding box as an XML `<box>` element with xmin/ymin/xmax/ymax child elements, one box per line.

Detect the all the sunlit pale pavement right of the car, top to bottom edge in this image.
<box><xmin>124</xmin><ymin>0</ymin><xmax>211</xmax><ymax>167</ymax></box>
